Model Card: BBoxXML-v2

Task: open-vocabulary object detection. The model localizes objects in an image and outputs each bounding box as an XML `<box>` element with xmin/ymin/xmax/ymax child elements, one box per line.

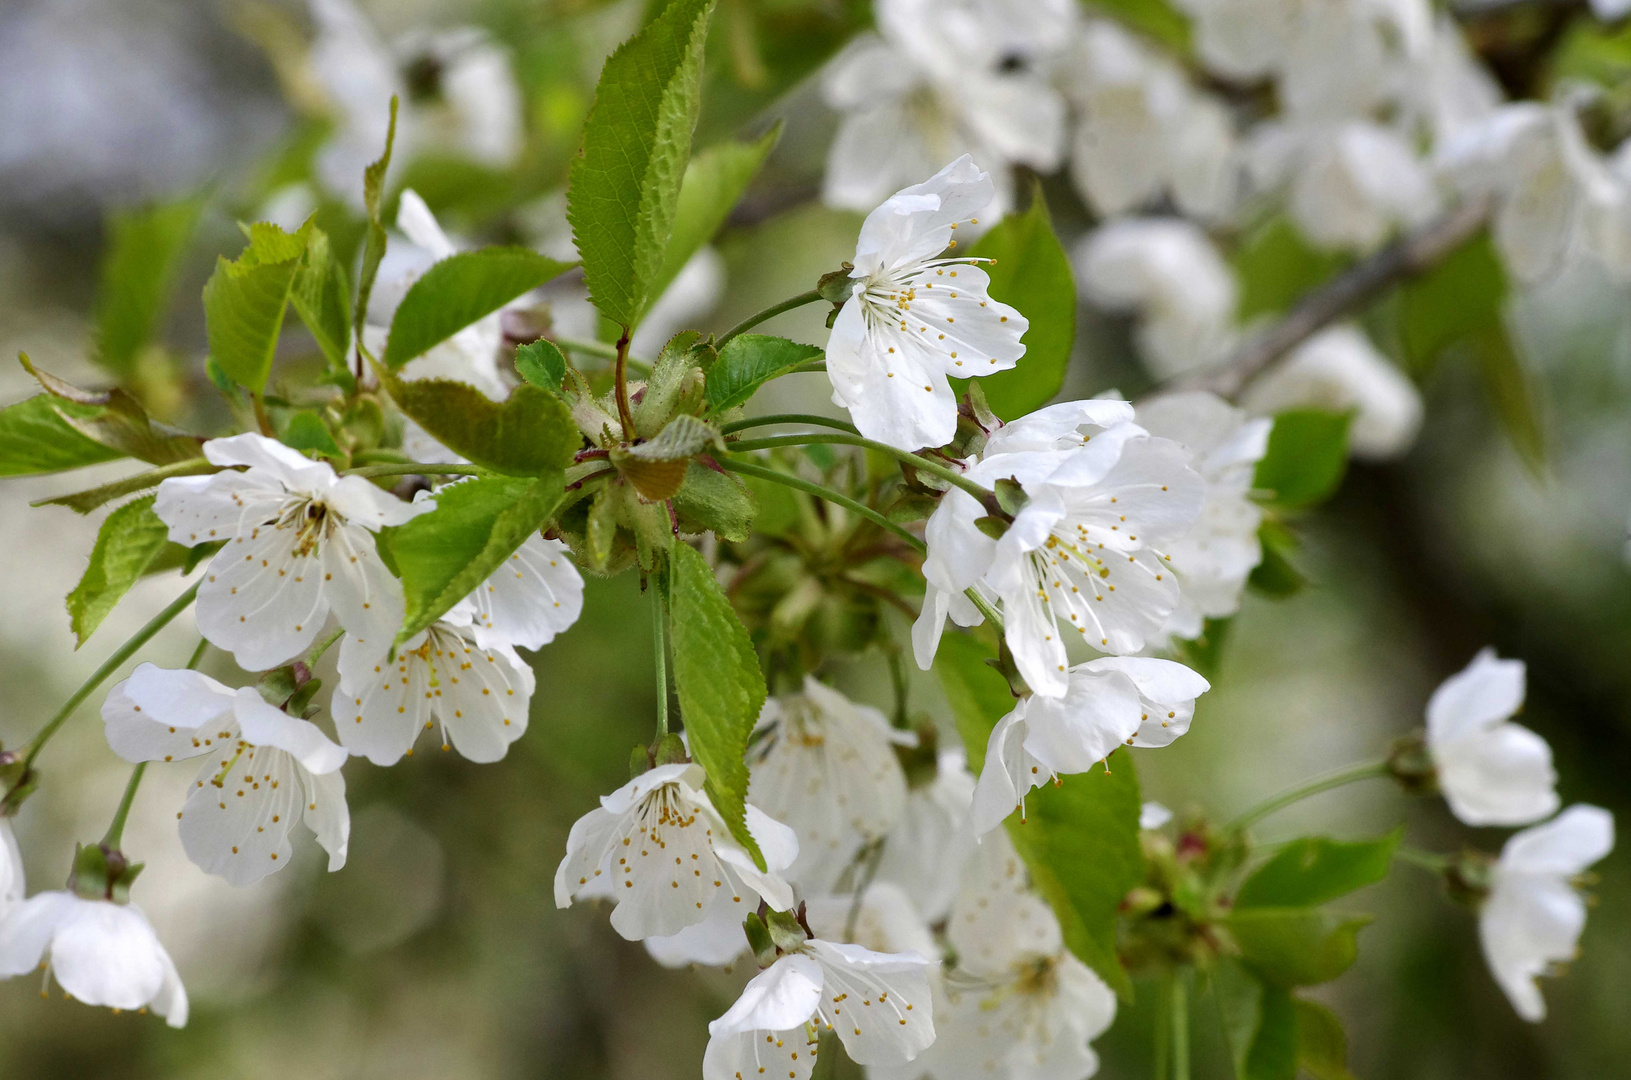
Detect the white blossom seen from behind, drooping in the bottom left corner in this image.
<box><xmin>0</xmin><ymin>892</ymin><xmax>188</xmax><ymax>1028</ymax></box>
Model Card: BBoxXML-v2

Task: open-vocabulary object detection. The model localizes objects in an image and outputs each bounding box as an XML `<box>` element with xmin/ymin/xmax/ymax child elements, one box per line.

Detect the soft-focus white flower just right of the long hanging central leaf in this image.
<box><xmin>749</xmin><ymin>675</ymin><xmax>917</xmax><ymax>896</ymax></box>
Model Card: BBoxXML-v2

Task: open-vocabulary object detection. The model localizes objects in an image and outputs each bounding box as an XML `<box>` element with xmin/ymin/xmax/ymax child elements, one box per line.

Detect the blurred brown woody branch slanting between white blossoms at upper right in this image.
<box><xmin>1181</xmin><ymin>199</ymin><xmax>1492</xmax><ymax>398</ymax></box>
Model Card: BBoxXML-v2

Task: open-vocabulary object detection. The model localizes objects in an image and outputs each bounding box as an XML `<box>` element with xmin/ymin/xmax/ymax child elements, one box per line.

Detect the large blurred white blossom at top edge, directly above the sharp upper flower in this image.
<box><xmin>822</xmin><ymin>0</ymin><xmax>1075</xmax><ymax>224</ymax></box>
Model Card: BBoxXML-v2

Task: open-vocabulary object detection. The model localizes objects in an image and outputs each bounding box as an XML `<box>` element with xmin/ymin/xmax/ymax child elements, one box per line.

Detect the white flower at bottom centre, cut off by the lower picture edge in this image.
<box><xmin>703</xmin><ymin>938</ymin><xmax>935</xmax><ymax>1080</ymax></box>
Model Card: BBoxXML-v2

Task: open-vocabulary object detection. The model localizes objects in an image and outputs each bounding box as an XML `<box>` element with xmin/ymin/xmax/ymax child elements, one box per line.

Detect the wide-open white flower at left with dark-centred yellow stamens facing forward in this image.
<box><xmin>153</xmin><ymin>434</ymin><xmax>435</xmax><ymax>671</ymax></box>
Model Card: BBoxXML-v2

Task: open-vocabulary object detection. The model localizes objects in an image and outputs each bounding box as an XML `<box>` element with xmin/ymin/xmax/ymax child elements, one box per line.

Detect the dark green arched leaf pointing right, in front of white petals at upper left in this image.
<box><xmin>385</xmin><ymin>248</ymin><xmax>571</xmax><ymax>370</ymax></box>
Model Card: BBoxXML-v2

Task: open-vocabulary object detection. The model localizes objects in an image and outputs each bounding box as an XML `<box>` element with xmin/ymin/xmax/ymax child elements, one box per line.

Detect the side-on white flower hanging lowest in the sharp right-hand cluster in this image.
<box><xmin>972</xmin><ymin>656</ymin><xmax>1210</xmax><ymax>835</ymax></box>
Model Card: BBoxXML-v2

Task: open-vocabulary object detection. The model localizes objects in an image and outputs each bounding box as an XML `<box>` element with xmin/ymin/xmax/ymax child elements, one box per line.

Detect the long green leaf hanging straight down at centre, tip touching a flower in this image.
<box><xmin>669</xmin><ymin>543</ymin><xmax>765</xmax><ymax>868</ymax></box>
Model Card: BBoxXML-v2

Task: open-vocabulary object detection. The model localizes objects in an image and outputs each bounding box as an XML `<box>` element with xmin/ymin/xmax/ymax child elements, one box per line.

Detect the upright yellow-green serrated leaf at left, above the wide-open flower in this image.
<box><xmin>204</xmin><ymin>222</ymin><xmax>308</xmax><ymax>393</ymax></box>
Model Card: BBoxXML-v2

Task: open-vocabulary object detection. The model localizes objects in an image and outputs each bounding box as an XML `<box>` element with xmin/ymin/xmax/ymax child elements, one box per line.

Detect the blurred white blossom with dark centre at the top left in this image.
<box><xmin>307</xmin><ymin>0</ymin><xmax>524</xmax><ymax>209</ymax></box>
